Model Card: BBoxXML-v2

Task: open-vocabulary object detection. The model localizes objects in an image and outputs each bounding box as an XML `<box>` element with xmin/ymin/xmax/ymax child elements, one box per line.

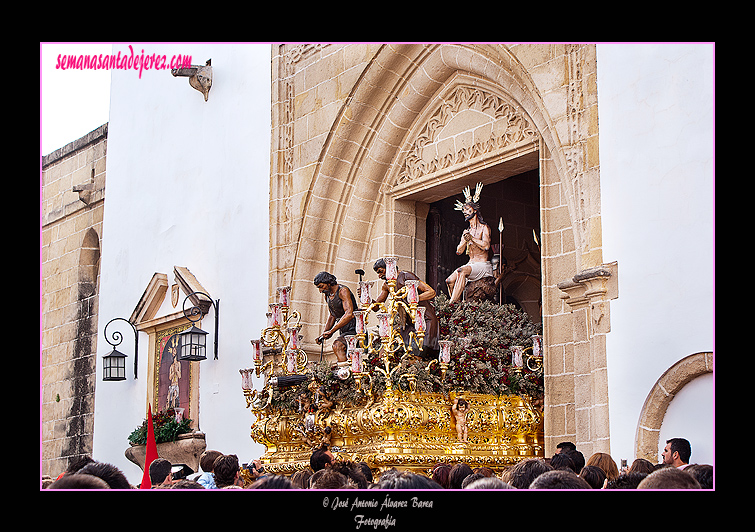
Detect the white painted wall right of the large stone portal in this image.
<box><xmin>597</xmin><ymin>44</ymin><xmax>714</xmax><ymax>464</ymax></box>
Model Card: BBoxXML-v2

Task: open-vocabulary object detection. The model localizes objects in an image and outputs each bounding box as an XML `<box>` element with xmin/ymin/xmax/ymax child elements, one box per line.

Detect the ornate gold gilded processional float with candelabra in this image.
<box><xmin>240</xmin><ymin>264</ymin><xmax>544</xmax><ymax>475</ymax></box>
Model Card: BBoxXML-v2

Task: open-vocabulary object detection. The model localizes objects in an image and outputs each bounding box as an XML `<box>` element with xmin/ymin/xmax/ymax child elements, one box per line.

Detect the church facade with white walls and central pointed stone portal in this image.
<box><xmin>41</xmin><ymin>43</ymin><xmax>714</xmax><ymax>484</ymax></box>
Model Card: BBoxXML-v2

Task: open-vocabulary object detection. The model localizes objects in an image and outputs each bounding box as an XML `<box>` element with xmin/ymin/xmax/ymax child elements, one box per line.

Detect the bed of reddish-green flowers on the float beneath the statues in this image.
<box><xmin>262</xmin><ymin>294</ymin><xmax>543</xmax><ymax>413</ymax></box>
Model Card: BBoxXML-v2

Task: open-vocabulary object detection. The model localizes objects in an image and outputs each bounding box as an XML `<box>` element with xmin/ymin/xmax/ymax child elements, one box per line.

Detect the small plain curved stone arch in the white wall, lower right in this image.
<box><xmin>635</xmin><ymin>352</ymin><xmax>713</xmax><ymax>463</ymax></box>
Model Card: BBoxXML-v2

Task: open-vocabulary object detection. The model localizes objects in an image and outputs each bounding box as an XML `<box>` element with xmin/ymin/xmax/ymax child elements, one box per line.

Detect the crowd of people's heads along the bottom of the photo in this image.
<box><xmin>42</xmin><ymin>438</ymin><xmax>713</xmax><ymax>490</ymax></box>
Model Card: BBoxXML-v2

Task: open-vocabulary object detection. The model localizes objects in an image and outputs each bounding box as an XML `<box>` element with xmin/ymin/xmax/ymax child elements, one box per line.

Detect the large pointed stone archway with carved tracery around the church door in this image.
<box><xmin>270</xmin><ymin>44</ymin><xmax>616</xmax><ymax>452</ymax></box>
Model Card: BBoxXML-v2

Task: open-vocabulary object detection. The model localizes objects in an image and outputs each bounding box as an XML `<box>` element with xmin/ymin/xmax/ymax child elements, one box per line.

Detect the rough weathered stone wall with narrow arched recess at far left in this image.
<box><xmin>41</xmin><ymin>124</ymin><xmax>107</xmax><ymax>477</ymax></box>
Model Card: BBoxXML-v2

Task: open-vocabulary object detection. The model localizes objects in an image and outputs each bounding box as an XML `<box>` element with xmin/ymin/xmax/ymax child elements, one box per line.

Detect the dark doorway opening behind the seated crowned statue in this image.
<box><xmin>427</xmin><ymin>169</ymin><xmax>541</xmax><ymax>322</ymax></box>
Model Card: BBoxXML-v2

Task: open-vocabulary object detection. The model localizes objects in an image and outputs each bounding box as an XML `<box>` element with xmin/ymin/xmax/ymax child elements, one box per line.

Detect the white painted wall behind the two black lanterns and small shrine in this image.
<box><xmin>93</xmin><ymin>43</ymin><xmax>271</xmax><ymax>484</ymax></box>
